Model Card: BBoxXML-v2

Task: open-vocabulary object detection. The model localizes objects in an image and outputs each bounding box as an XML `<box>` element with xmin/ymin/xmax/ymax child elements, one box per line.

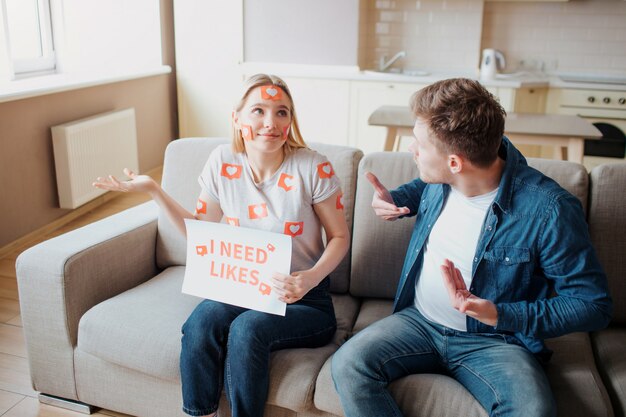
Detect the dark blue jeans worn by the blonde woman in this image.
<box><xmin>180</xmin><ymin>286</ymin><xmax>336</xmax><ymax>417</ymax></box>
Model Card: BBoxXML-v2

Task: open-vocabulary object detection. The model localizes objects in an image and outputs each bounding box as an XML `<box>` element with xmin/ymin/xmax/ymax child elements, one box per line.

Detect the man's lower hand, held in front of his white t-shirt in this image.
<box><xmin>441</xmin><ymin>259</ymin><xmax>498</xmax><ymax>327</ymax></box>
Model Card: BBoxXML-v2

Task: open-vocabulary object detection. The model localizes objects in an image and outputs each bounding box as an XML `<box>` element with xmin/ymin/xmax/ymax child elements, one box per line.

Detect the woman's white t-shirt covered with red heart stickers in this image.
<box><xmin>198</xmin><ymin>145</ymin><xmax>343</xmax><ymax>272</ymax></box>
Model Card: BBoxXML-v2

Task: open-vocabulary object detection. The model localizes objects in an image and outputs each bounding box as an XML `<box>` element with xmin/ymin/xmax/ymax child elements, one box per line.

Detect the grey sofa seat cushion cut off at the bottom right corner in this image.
<box><xmin>591</xmin><ymin>326</ymin><xmax>626</xmax><ymax>417</ymax></box>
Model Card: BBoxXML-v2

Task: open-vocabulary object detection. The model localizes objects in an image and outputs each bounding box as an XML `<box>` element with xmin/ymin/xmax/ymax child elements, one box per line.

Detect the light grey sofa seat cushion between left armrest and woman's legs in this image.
<box><xmin>77</xmin><ymin>267</ymin><xmax>201</xmax><ymax>380</ymax></box>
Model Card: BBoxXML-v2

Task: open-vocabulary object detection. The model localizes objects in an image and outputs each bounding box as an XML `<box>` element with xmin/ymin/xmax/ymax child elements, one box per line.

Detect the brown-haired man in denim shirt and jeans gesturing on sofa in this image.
<box><xmin>332</xmin><ymin>79</ymin><xmax>611</xmax><ymax>417</ymax></box>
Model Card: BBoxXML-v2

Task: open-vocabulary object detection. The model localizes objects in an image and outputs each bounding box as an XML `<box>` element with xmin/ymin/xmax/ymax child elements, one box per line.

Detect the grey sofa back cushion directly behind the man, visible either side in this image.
<box><xmin>350</xmin><ymin>152</ymin><xmax>589</xmax><ymax>299</ymax></box>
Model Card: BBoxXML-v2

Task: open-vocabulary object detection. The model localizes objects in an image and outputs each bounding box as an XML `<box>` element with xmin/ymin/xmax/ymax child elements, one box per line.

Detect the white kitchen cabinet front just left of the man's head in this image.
<box><xmin>349</xmin><ymin>81</ymin><xmax>427</xmax><ymax>153</ymax></box>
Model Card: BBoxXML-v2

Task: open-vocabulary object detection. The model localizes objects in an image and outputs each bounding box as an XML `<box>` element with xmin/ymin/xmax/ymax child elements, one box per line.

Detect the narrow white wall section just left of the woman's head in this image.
<box><xmin>174</xmin><ymin>0</ymin><xmax>243</xmax><ymax>137</ymax></box>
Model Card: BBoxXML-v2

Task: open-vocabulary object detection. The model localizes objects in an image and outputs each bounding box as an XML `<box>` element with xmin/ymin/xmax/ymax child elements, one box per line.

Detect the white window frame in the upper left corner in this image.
<box><xmin>0</xmin><ymin>0</ymin><xmax>56</xmax><ymax>79</ymax></box>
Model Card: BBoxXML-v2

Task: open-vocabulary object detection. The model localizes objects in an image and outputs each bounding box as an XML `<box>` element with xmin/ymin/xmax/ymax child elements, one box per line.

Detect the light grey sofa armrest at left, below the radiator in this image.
<box><xmin>16</xmin><ymin>202</ymin><xmax>158</xmax><ymax>399</ymax></box>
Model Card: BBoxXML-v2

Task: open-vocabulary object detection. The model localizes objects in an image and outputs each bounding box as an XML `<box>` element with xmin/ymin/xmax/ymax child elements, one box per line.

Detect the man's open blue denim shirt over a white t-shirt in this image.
<box><xmin>391</xmin><ymin>137</ymin><xmax>611</xmax><ymax>359</ymax></box>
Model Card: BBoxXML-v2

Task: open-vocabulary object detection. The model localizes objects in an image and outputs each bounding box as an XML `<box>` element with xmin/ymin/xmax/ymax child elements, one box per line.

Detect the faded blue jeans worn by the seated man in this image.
<box><xmin>332</xmin><ymin>306</ymin><xmax>556</xmax><ymax>417</ymax></box>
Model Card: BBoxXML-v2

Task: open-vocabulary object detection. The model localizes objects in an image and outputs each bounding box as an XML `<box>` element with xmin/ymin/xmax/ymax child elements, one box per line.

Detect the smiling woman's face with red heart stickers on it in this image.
<box><xmin>235</xmin><ymin>85</ymin><xmax>291</xmax><ymax>153</ymax></box>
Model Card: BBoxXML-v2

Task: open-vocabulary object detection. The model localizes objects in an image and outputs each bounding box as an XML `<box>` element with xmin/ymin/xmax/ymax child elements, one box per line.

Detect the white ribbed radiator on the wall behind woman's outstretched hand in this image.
<box><xmin>52</xmin><ymin>108</ymin><xmax>139</xmax><ymax>209</ymax></box>
